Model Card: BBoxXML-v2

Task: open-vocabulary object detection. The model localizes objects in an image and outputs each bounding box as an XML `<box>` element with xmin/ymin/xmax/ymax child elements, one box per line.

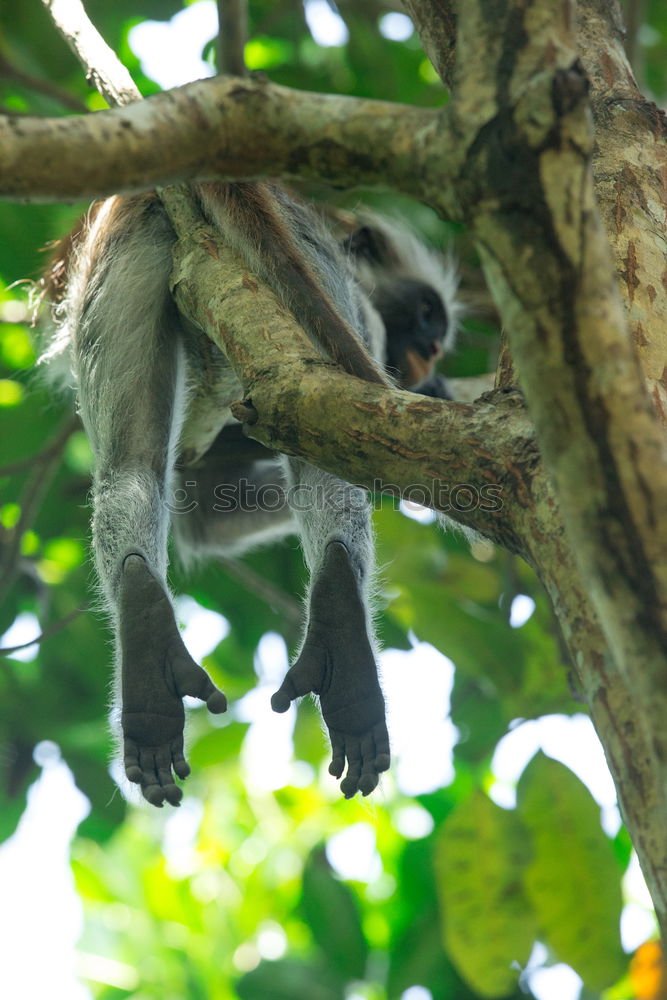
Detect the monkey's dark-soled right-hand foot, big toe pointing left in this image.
<box><xmin>271</xmin><ymin>542</ymin><xmax>390</xmax><ymax>799</ymax></box>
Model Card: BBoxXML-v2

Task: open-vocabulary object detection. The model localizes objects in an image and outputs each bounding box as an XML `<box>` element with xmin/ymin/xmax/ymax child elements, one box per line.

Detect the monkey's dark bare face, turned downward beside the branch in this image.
<box><xmin>372</xmin><ymin>278</ymin><xmax>449</xmax><ymax>389</ymax></box>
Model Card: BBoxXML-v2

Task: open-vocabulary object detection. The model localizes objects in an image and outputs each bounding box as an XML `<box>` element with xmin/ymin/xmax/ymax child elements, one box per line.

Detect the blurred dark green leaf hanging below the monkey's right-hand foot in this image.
<box><xmin>301</xmin><ymin>847</ymin><xmax>368</xmax><ymax>980</ymax></box>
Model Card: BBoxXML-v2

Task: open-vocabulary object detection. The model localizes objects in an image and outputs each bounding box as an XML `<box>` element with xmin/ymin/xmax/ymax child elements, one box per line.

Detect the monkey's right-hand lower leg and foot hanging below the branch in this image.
<box><xmin>271</xmin><ymin>459</ymin><xmax>390</xmax><ymax>798</ymax></box>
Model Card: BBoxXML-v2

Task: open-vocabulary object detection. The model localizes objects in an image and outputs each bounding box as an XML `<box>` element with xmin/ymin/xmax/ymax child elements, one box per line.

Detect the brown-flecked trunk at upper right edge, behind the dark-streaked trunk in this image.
<box><xmin>577</xmin><ymin>0</ymin><xmax>667</xmax><ymax>406</ymax></box>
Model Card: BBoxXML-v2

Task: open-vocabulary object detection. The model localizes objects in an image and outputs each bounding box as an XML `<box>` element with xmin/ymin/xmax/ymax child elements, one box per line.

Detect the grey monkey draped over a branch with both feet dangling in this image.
<box><xmin>43</xmin><ymin>182</ymin><xmax>457</xmax><ymax>807</ymax></box>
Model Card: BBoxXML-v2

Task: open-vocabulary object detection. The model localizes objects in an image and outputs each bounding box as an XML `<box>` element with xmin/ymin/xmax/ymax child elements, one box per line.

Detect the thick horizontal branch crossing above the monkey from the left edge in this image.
<box><xmin>0</xmin><ymin>77</ymin><xmax>446</xmax><ymax>202</ymax></box>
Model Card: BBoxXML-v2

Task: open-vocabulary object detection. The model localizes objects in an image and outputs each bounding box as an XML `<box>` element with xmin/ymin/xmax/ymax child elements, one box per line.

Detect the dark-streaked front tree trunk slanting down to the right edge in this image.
<box><xmin>452</xmin><ymin>0</ymin><xmax>667</xmax><ymax>929</ymax></box>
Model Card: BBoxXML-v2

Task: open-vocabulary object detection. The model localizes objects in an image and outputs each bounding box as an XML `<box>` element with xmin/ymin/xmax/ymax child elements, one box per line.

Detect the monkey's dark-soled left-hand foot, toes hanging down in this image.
<box><xmin>119</xmin><ymin>553</ymin><xmax>227</xmax><ymax>807</ymax></box>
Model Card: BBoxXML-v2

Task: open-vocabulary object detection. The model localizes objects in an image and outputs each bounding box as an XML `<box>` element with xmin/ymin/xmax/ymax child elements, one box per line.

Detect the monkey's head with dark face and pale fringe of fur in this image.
<box><xmin>346</xmin><ymin>217</ymin><xmax>460</xmax><ymax>390</ymax></box>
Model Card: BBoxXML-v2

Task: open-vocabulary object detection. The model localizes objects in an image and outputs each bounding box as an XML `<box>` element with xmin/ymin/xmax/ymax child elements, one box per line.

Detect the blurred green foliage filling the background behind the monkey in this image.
<box><xmin>0</xmin><ymin>0</ymin><xmax>667</xmax><ymax>1000</ymax></box>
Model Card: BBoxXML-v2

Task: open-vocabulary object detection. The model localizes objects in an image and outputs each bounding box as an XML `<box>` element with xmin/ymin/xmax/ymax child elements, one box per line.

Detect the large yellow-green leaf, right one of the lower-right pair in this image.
<box><xmin>518</xmin><ymin>753</ymin><xmax>626</xmax><ymax>992</ymax></box>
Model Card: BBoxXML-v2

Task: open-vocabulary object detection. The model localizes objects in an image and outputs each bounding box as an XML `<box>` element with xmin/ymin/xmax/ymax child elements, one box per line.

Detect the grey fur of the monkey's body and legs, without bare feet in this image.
<box><xmin>42</xmin><ymin>185</ymin><xmax>458</xmax><ymax>805</ymax></box>
